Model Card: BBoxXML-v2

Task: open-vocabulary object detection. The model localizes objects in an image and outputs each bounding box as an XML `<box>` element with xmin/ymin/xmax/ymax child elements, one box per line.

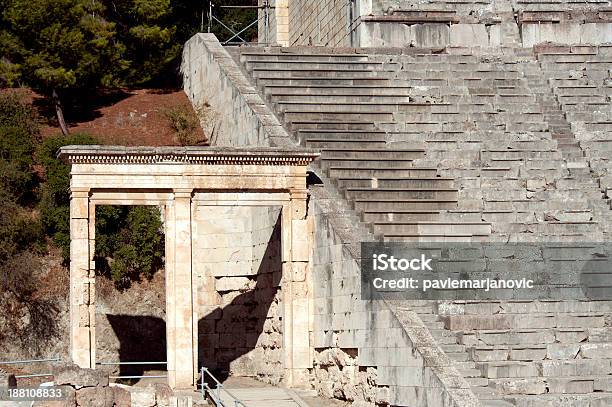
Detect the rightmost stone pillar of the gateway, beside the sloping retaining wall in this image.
<box><xmin>281</xmin><ymin>190</ymin><xmax>312</xmax><ymax>387</ymax></box>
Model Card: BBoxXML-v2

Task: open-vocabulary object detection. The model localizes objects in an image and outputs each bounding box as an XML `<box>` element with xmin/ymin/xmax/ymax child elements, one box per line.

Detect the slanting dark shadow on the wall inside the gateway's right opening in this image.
<box><xmin>198</xmin><ymin>216</ymin><xmax>282</xmax><ymax>385</ymax></box>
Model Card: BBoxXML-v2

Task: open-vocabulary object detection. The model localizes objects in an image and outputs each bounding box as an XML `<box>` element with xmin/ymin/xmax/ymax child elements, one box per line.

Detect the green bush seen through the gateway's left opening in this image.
<box><xmin>96</xmin><ymin>206</ymin><xmax>164</xmax><ymax>288</ymax></box>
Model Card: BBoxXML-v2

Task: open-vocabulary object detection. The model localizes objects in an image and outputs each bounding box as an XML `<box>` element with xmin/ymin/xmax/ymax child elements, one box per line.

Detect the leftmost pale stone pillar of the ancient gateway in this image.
<box><xmin>70</xmin><ymin>188</ymin><xmax>96</xmax><ymax>369</ymax></box>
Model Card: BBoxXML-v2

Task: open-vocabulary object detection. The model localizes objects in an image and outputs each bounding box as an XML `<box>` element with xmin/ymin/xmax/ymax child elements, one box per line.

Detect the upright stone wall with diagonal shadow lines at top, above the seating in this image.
<box><xmin>289</xmin><ymin>0</ymin><xmax>350</xmax><ymax>47</ymax></box>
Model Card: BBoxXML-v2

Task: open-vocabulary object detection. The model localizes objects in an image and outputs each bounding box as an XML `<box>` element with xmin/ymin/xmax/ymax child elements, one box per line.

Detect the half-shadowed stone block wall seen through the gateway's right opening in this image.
<box><xmin>194</xmin><ymin>206</ymin><xmax>282</xmax><ymax>383</ymax></box>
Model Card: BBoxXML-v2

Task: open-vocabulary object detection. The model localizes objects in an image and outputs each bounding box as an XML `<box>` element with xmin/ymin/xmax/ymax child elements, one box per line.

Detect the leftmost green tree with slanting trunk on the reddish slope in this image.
<box><xmin>0</xmin><ymin>0</ymin><xmax>129</xmax><ymax>134</ymax></box>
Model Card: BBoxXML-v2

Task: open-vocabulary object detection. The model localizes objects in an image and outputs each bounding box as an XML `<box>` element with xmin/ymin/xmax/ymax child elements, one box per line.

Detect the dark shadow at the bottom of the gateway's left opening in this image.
<box><xmin>106</xmin><ymin>314</ymin><xmax>166</xmax><ymax>376</ymax></box>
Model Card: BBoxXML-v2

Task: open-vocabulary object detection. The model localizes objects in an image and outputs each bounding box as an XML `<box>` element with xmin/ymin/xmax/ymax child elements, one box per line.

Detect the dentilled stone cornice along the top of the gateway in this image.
<box><xmin>57</xmin><ymin>145</ymin><xmax>319</xmax><ymax>166</ymax></box>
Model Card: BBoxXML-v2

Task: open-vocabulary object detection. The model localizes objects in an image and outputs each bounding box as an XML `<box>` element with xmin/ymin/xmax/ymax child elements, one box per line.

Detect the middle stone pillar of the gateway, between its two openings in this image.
<box><xmin>166</xmin><ymin>189</ymin><xmax>197</xmax><ymax>390</ymax></box>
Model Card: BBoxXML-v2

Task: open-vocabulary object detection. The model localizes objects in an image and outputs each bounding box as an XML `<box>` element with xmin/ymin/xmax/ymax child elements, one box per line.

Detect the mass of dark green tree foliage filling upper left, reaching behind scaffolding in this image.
<box><xmin>0</xmin><ymin>0</ymin><xmax>257</xmax><ymax>91</ymax></box>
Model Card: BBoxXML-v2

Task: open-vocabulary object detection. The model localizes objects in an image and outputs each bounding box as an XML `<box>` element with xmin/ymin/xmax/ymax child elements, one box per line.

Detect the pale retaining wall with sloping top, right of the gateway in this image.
<box><xmin>309</xmin><ymin>186</ymin><xmax>476</xmax><ymax>407</ymax></box>
